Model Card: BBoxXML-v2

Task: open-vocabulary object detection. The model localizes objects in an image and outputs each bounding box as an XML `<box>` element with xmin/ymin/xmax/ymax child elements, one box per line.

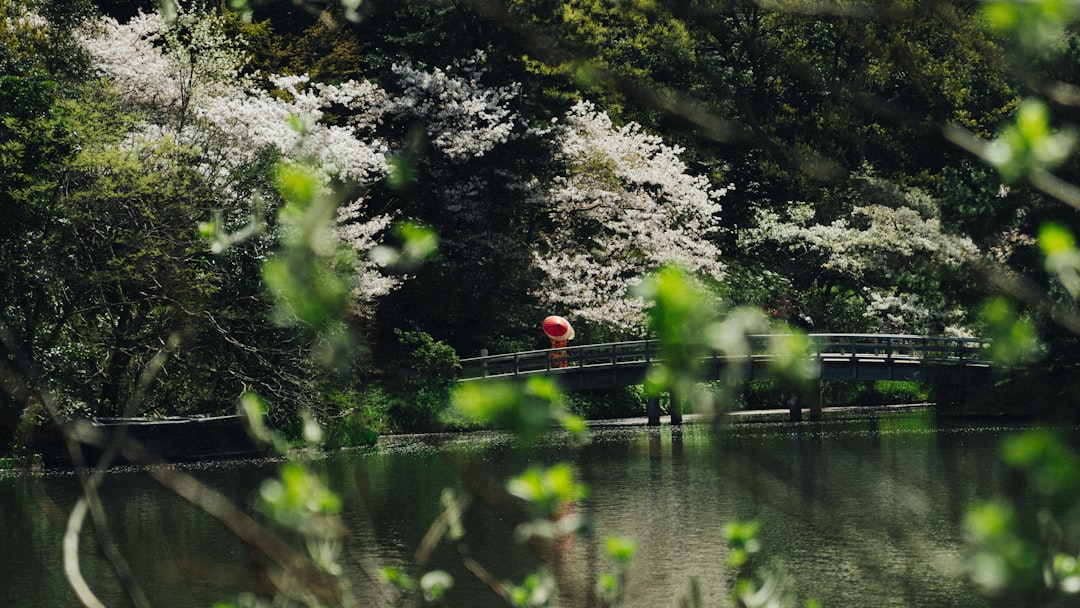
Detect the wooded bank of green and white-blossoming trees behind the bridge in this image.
<box><xmin>6</xmin><ymin>0</ymin><xmax>1076</xmax><ymax>442</ymax></box>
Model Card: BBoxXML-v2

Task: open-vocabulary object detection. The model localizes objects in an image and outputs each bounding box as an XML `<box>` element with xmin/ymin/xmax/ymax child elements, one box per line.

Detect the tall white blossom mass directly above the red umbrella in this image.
<box><xmin>536</xmin><ymin>102</ymin><xmax>730</xmax><ymax>329</ymax></box>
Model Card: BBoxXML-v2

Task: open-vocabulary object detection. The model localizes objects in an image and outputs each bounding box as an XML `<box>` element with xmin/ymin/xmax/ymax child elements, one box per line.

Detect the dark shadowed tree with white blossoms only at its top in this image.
<box><xmin>367</xmin><ymin>52</ymin><xmax>550</xmax><ymax>352</ymax></box>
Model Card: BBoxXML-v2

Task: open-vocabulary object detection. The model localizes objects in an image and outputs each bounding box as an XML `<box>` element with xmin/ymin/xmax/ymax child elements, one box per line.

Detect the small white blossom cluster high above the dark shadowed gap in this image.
<box><xmin>388</xmin><ymin>51</ymin><xmax>522</xmax><ymax>161</ymax></box>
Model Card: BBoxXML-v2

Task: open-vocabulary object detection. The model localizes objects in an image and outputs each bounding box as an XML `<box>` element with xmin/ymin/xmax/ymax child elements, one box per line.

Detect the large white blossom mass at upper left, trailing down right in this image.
<box><xmin>80</xmin><ymin>11</ymin><xmax>400</xmax><ymax>311</ymax></box>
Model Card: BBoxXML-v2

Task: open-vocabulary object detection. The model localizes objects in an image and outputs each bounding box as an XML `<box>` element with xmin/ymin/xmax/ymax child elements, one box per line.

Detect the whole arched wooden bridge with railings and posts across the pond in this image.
<box><xmin>461</xmin><ymin>334</ymin><xmax>990</xmax><ymax>423</ymax></box>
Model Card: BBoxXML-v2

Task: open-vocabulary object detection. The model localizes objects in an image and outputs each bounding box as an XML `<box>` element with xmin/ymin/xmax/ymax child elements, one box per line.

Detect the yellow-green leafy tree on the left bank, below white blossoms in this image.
<box><xmin>19</xmin><ymin>87</ymin><xmax>265</xmax><ymax>415</ymax></box>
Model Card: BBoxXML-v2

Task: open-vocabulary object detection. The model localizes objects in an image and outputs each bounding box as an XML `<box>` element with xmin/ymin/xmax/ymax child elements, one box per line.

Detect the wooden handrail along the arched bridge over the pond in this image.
<box><xmin>460</xmin><ymin>334</ymin><xmax>988</xmax><ymax>379</ymax></box>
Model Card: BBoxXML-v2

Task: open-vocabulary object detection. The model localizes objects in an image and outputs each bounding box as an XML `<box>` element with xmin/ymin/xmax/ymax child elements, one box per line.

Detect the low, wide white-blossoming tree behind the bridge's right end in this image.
<box><xmin>739</xmin><ymin>175</ymin><xmax>980</xmax><ymax>334</ymax></box>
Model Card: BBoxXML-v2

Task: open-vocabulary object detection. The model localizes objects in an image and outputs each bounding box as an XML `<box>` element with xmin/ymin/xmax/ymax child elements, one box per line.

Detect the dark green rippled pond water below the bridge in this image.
<box><xmin>0</xmin><ymin>410</ymin><xmax>1049</xmax><ymax>608</ymax></box>
